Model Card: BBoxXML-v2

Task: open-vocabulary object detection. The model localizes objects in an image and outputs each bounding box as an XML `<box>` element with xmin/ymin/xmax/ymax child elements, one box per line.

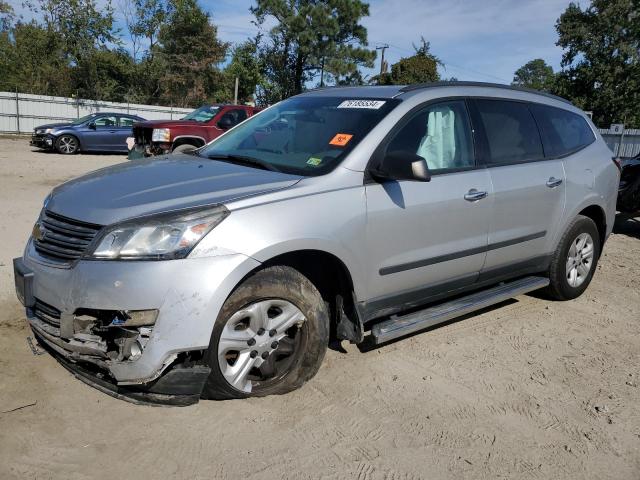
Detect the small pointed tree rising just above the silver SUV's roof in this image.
<box><xmin>373</xmin><ymin>38</ymin><xmax>442</xmax><ymax>85</ymax></box>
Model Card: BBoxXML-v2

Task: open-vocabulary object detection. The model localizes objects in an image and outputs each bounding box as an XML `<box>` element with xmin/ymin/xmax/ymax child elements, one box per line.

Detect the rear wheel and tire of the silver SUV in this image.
<box><xmin>547</xmin><ymin>215</ymin><xmax>601</xmax><ymax>300</ymax></box>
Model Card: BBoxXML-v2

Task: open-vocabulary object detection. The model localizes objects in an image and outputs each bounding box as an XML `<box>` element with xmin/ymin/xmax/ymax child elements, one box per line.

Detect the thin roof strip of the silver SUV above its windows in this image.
<box><xmin>302</xmin><ymin>82</ymin><xmax>570</xmax><ymax>103</ymax></box>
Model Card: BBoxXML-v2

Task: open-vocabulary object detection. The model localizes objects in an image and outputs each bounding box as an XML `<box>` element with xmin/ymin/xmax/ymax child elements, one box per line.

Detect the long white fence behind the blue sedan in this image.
<box><xmin>0</xmin><ymin>92</ymin><xmax>191</xmax><ymax>133</ymax></box>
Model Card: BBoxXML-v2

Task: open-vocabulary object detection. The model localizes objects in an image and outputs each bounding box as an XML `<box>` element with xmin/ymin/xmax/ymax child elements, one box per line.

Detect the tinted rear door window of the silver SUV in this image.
<box><xmin>475</xmin><ymin>100</ymin><xmax>544</xmax><ymax>165</ymax></box>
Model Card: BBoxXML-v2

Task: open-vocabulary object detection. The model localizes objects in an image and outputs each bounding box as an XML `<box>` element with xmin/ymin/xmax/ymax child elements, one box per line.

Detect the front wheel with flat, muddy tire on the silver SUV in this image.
<box><xmin>202</xmin><ymin>266</ymin><xmax>329</xmax><ymax>400</ymax></box>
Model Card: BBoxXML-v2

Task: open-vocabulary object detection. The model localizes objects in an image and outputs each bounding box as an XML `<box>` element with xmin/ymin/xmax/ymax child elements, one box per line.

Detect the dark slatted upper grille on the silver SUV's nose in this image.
<box><xmin>33</xmin><ymin>210</ymin><xmax>102</xmax><ymax>262</ymax></box>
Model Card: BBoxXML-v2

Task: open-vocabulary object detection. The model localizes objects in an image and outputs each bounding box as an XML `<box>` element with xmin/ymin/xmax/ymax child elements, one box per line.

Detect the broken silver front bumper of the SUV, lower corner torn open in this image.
<box><xmin>14</xmin><ymin>242</ymin><xmax>258</xmax><ymax>405</ymax></box>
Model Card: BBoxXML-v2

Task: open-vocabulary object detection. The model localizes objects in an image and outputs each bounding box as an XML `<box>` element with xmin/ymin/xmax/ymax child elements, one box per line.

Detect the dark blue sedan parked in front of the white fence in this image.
<box><xmin>30</xmin><ymin>112</ymin><xmax>145</xmax><ymax>155</ymax></box>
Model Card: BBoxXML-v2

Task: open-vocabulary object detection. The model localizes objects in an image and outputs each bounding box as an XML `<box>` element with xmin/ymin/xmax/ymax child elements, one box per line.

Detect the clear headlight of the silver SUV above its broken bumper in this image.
<box><xmin>90</xmin><ymin>206</ymin><xmax>229</xmax><ymax>260</ymax></box>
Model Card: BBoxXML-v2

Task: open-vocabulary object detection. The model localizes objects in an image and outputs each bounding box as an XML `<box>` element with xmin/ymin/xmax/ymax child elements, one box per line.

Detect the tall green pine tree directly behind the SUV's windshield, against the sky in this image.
<box><xmin>251</xmin><ymin>0</ymin><xmax>375</xmax><ymax>99</ymax></box>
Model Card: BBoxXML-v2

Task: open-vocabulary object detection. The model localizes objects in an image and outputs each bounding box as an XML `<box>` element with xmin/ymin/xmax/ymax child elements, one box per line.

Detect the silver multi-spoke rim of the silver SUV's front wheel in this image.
<box><xmin>218</xmin><ymin>299</ymin><xmax>307</xmax><ymax>393</ymax></box>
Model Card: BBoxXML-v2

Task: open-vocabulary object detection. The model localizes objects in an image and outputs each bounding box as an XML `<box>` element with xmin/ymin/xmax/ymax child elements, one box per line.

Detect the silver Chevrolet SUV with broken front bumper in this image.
<box><xmin>14</xmin><ymin>83</ymin><xmax>619</xmax><ymax>404</ymax></box>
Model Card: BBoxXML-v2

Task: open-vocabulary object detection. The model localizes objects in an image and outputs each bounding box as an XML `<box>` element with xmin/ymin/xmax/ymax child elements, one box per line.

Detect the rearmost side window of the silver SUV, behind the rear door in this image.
<box><xmin>531</xmin><ymin>105</ymin><xmax>596</xmax><ymax>157</ymax></box>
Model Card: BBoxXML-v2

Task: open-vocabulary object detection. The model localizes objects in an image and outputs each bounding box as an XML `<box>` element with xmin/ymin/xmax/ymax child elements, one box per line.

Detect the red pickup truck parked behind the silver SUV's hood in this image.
<box><xmin>129</xmin><ymin>105</ymin><xmax>260</xmax><ymax>159</ymax></box>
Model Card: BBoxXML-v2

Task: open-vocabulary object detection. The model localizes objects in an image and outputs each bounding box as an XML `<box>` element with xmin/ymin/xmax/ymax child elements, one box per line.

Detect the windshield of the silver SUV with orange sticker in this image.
<box><xmin>198</xmin><ymin>97</ymin><xmax>400</xmax><ymax>176</ymax></box>
